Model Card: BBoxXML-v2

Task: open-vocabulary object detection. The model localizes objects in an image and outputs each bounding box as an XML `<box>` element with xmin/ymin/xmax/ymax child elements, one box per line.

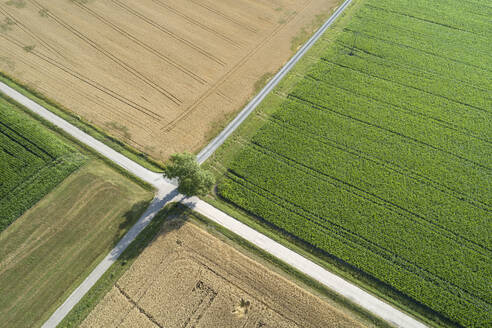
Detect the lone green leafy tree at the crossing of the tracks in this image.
<box><xmin>164</xmin><ymin>153</ymin><xmax>215</xmax><ymax>197</ymax></box>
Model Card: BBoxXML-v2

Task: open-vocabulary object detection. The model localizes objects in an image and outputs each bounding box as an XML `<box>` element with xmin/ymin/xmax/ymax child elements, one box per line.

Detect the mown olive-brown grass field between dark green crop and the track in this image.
<box><xmin>0</xmin><ymin>160</ymin><xmax>152</xmax><ymax>327</ymax></box>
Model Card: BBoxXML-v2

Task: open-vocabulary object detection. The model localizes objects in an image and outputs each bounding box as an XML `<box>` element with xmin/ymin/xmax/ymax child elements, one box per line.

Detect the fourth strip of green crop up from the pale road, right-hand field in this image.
<box><xmin>273</xmin><ymin>98</ymin><xmax>492</xmax><ymax>208</ymax></box>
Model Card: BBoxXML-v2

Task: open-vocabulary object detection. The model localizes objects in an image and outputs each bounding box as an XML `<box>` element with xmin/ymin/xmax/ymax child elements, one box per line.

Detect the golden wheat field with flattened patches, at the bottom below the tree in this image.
<box><xmin>81</xmin><ymin>215</ymin><xmax>370</xmax><ymax>328</ymax></box>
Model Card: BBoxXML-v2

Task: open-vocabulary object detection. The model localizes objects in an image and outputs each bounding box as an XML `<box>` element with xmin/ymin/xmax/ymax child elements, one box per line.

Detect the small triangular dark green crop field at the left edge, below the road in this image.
<box><xmin>0</xmin><ymin>97</ymin><xmax>86</xmax><ymax>232</ymax></box>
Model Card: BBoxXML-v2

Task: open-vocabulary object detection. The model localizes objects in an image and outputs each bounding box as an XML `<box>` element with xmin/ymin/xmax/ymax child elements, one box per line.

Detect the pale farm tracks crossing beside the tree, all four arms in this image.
<box><xmin>0</xmin><ymin>0</ymin><xmax>426</xmax><ymax>328</ymax></box>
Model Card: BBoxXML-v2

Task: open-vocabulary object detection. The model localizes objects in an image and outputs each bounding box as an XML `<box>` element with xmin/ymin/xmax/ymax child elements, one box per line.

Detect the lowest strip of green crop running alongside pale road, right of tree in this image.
<box><xmin>219</xmin><ymin>170</ymin><xmax>490</xmax><ymax>326</ymax></box>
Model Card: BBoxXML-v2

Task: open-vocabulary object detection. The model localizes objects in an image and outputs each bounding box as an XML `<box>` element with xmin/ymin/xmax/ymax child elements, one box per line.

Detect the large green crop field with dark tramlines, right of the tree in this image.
<box><xmin>217</xmin><ymin>0</ymin><xmax>492</xmax><ymax>327</ymax></box>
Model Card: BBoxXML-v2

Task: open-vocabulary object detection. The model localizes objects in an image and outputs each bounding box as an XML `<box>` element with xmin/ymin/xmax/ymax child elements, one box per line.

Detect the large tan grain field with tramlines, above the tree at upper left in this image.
<box><xmin>0</xmin><ymin>0</ymin><xmax>337</xmax><ymax>159</ymax></box>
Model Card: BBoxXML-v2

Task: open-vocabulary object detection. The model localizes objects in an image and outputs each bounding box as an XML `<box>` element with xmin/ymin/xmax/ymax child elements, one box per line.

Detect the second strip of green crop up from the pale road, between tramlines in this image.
<box><xmin>230</xmin><ymin>142</ymin><xmax>492</xmax><ymax>300</ymax></box>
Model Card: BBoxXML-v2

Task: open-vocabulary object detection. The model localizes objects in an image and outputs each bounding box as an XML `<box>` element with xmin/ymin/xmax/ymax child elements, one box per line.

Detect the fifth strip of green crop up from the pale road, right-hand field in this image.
<box><xmin>291</xmin><ymin>80</ymin><xmax>492</xmax><ymax>174</ymax></box>
